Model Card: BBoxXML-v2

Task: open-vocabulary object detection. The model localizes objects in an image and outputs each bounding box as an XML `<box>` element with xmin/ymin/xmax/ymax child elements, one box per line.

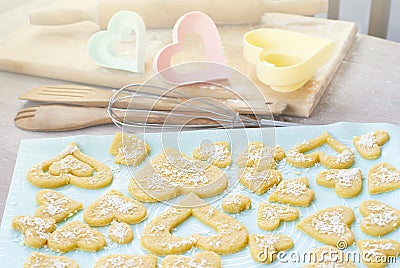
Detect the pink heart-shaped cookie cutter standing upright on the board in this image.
<box><xmin>153</xmin><ymin>11</ymin><xmax>230</xmax><ymax>84</ymax></box>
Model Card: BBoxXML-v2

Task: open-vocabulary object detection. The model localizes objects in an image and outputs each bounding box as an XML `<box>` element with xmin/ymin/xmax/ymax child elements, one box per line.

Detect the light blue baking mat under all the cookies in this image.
<box><xmin>0</xmin><ymin>123</ymin><xmax>400</xmax><ymax>267</ymax></box>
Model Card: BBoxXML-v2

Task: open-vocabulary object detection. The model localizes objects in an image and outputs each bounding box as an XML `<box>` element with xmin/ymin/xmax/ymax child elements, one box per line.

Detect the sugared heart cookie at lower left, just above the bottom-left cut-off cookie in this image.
<box><xmin>47</xmin><ymin>221</ymin><xmax>106</xmax><ymax>252</ymax></box>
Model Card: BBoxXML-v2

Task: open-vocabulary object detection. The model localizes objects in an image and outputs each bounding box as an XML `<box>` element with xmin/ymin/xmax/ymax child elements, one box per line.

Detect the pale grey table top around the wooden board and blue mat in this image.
<box><xmin>0</xmin><ymin>0</ymin><xmax>400</xmax><ymax>222</ymax></box>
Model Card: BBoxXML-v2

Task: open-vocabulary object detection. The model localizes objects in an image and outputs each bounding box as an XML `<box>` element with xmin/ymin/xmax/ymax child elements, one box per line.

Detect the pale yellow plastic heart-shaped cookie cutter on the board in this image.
<box><xmin>243</xmin><ymin>29</ymin><xmax>335</xmax><ymax>92</ymax></box>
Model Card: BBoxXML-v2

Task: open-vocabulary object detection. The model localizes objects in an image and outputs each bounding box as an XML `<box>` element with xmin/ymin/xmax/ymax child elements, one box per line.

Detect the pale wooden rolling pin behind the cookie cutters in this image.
<box><xmin>30</xmin><ymin>0</ymin><xmax>328</xmax><ymax>29</ymax></box>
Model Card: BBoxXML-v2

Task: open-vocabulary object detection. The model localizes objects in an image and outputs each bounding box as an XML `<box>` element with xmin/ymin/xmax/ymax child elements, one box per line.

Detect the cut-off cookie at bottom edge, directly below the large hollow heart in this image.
<box><xmin>162</xmin><ymin>251</ymin><xmax>221</xmax><ymax>268</ymax></box>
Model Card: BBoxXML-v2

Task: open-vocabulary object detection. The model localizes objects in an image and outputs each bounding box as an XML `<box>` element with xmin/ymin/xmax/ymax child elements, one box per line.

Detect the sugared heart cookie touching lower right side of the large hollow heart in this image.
<box><xmin>249</xmin><ymin>234</ymin><xmax>294</xmax><ymax>263</ymax></box>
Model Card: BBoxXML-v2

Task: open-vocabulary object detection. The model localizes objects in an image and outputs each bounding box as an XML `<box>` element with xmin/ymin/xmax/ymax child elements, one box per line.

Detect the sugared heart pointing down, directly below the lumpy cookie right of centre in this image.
<box><xmin>238</xmin><ymin>167</ymin><xmax>282</xmax><ymax>195</ymax></box>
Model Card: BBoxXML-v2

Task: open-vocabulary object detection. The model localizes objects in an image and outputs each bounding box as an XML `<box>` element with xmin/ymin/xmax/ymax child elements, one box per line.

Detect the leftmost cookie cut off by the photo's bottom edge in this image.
<box><xmin>24</xmin><ymin>252</ymin><xmax>79</xmax><ymax>268</ymax></box>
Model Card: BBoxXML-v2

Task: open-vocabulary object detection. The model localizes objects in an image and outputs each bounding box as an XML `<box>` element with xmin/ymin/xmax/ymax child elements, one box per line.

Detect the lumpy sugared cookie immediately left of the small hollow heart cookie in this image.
<box><xmin>236</xmin><ymin>141</ymin><xmax>285</xmax><ymax>171</ymax></box>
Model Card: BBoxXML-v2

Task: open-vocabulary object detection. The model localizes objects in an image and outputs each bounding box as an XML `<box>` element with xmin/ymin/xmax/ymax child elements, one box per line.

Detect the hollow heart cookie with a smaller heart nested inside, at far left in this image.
<box><xmin>27</xmin><ymin>142</ymin><xmax>113</xmax><ymax>189</ymax></box>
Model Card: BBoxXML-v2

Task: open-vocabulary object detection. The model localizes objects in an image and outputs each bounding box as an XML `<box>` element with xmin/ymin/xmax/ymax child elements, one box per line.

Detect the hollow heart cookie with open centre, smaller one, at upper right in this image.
<box><xmin>286</xmin><ymin>132</ymin><xmax>354</xmax><ymax>169</ymax></box>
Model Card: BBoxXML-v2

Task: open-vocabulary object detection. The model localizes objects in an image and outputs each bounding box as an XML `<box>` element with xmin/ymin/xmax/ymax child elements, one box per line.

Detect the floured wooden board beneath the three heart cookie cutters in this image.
<box><xmin>0</xmin><ymin>13</ymin><xmax>357</xmax><ymax>117</ymax></box>
